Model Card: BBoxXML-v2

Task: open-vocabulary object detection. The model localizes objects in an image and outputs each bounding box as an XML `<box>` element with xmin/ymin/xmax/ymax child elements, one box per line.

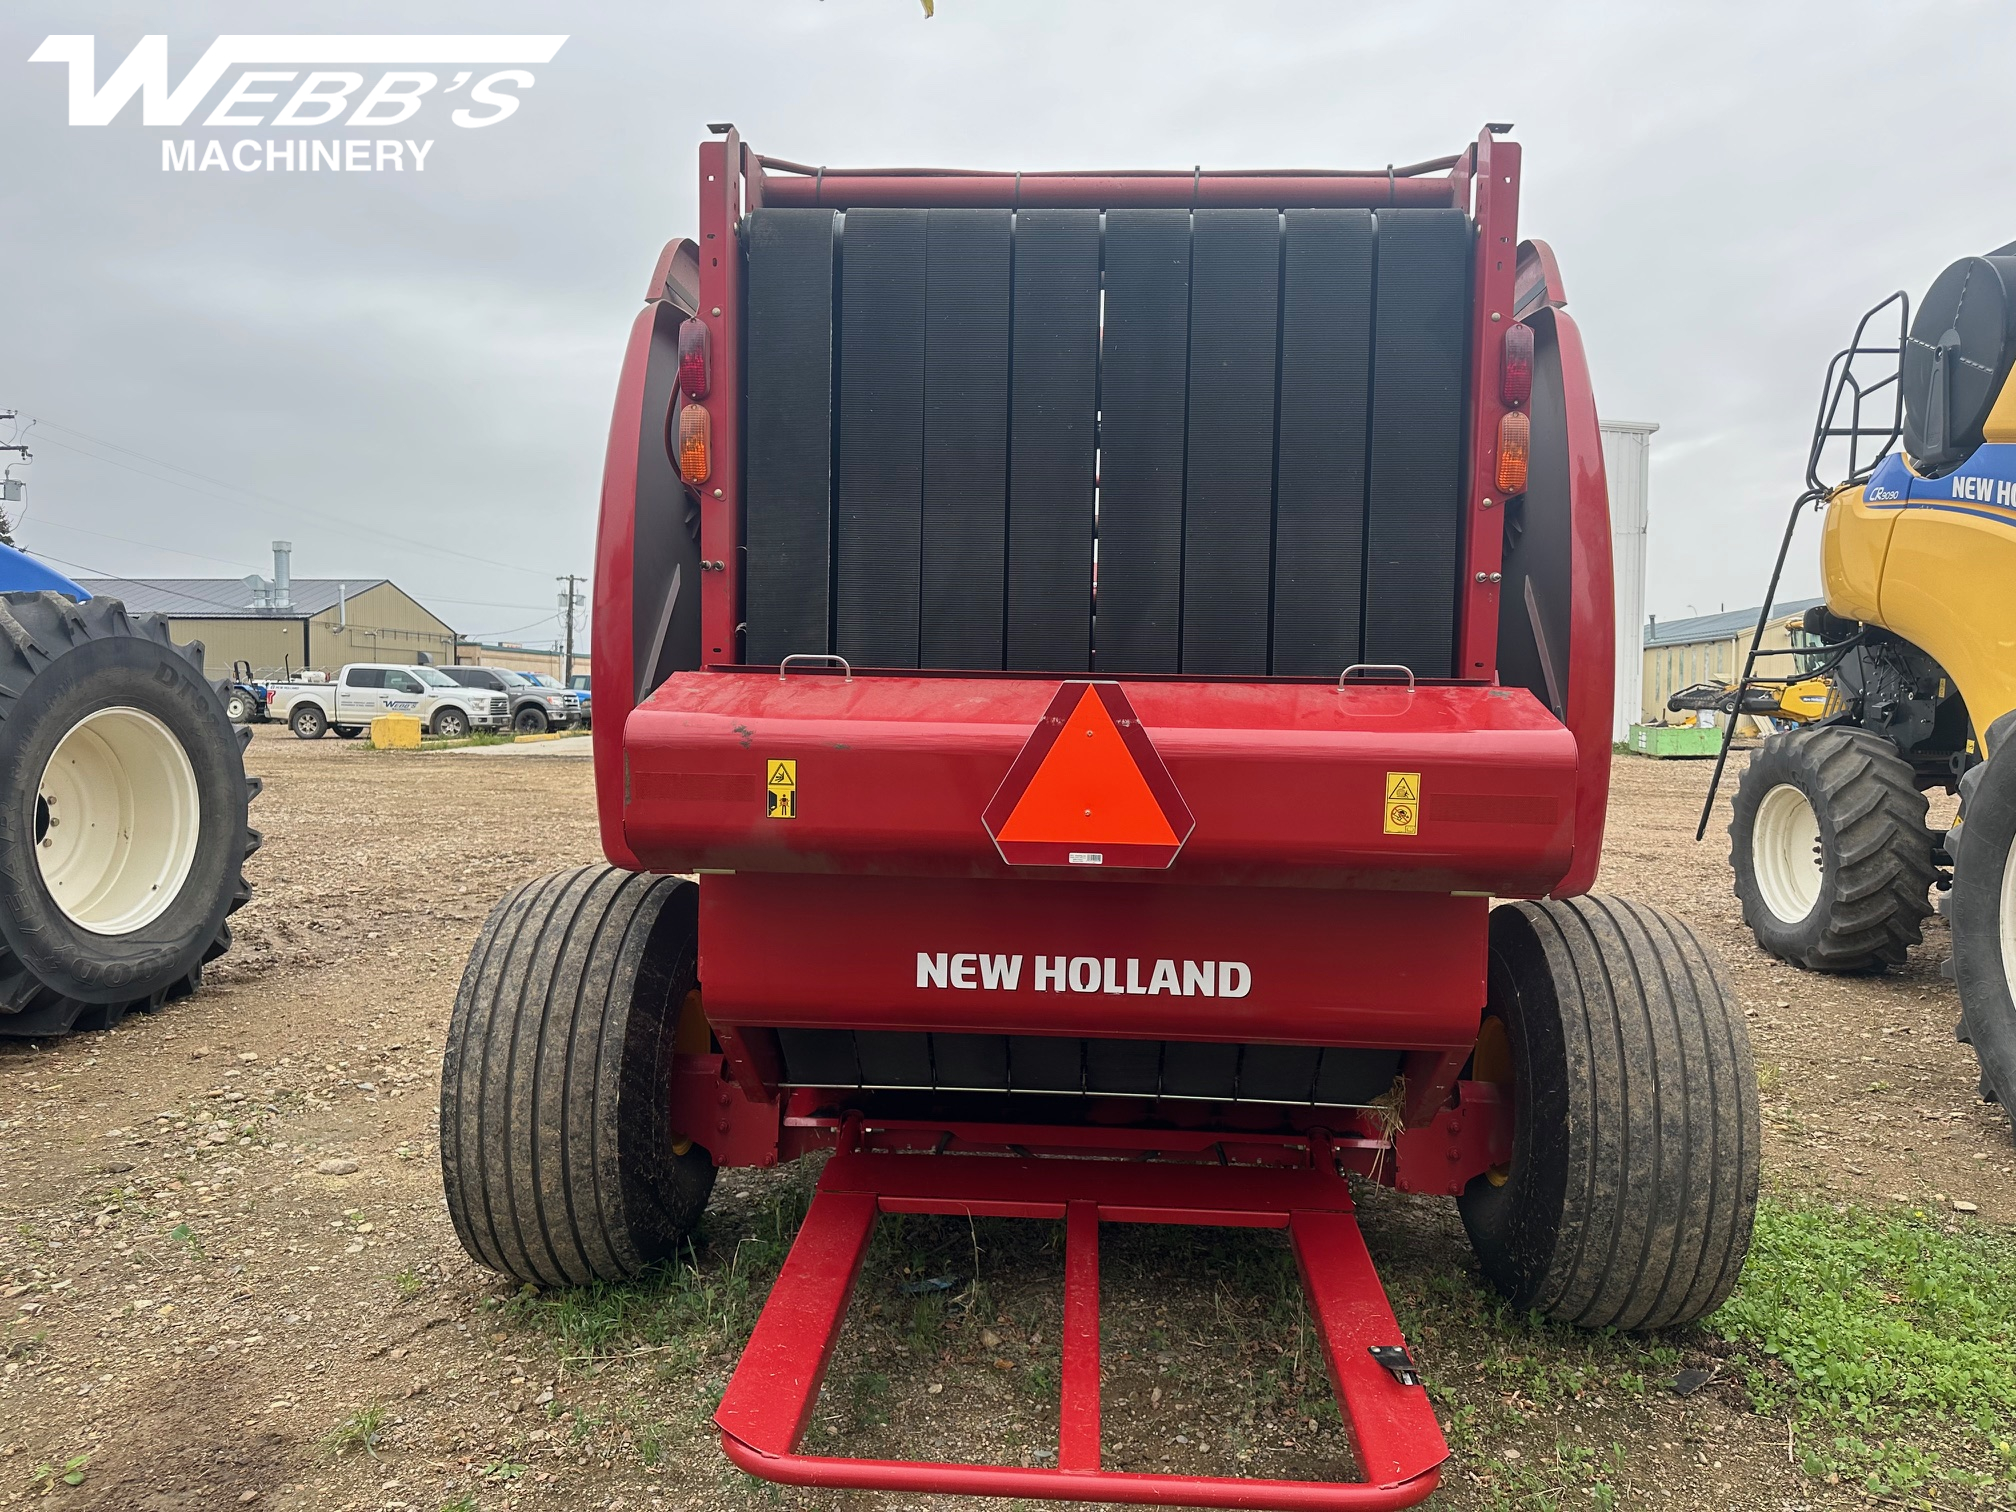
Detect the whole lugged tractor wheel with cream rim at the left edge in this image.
<box><xmin>0</xmin><ymin>593</ymin><xmax>260</xmax><ymax>1036</ymax></box>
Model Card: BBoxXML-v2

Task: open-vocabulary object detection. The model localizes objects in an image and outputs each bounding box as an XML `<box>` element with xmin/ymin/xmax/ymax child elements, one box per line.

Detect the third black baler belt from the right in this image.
<box><xmin>1183</xmin><ymin>210</ymin><xmax>1280</xmax><ymax>677</ymax></box>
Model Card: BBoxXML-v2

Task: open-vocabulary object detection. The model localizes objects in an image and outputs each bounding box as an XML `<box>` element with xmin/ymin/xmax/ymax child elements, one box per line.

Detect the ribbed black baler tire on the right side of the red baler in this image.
<box><xmin>1458</xmin><ymin>897</ymin><xmax>1760</xmax><ymax>1331</ymax></box>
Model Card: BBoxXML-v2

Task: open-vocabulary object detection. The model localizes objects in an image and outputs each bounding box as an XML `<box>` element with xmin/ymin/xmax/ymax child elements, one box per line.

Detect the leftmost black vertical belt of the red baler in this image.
<box><xmin>741</xmin><ymin>210</ymin><xmax>833</xmax><ymax>663</ymax></box>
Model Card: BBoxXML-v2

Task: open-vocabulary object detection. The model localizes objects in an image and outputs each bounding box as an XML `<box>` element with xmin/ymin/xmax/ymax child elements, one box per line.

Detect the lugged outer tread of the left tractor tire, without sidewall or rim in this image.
<box><xmin>0</xmin><ymin>593</ymin><xmax>264</xmax><ymax>1038</ymax></box>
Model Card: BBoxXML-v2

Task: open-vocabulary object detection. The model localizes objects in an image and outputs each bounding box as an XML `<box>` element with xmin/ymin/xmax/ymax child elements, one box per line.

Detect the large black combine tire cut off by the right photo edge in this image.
<box><xmin>1949</xmin><ymin>744</ymin><xmax>2016</xmax><ymax>1119</ymax></box>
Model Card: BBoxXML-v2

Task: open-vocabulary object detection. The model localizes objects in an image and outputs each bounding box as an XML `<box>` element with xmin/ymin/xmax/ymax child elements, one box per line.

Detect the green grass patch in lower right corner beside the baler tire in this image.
<box><xmin>1710</xmin><ymin>1202</ymin><xmax>2016</xmax><ymax>1496</ymax></box>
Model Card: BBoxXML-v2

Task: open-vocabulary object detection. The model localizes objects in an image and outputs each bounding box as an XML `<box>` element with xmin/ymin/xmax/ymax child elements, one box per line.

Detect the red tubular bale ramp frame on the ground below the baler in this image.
<box><xmin>714</xmin><ymin>1131</ymin><xmax>1447</xmax><ymax>1508</ymax></box>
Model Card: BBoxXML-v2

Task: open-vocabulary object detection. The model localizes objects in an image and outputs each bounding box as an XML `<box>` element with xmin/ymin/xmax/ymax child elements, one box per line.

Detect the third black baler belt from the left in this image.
<box><xmin>917</xmin><ymin>210</ymin><xmax>1012</xmax><ymax>669</ymax></box>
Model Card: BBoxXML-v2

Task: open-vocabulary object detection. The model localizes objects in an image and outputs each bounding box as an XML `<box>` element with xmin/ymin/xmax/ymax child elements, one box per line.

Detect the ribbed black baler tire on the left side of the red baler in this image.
<box><xmin>442</xmin><ymin>867</ymin><xmax>714</xmax><ymax>1286</ymax></box>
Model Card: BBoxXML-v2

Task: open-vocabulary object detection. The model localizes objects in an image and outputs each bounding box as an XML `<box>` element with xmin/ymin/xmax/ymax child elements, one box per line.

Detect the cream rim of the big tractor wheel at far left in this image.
<box><xmin>34</xmin><ymin>708</ymin><xmax>202</xmax><ymax>935</ymax></box>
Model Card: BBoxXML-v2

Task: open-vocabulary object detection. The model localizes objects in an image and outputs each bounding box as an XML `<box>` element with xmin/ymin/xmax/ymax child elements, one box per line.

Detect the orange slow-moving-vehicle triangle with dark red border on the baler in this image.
<box><xmin>984</xmin><ymin>681</ymin><xmax>1195</xmax><ymax>867</ymax></box>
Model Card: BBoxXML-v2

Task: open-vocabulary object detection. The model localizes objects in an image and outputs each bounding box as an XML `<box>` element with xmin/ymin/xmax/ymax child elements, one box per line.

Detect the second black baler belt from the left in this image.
<box><xmin>835</xmin><ymin>210</ymin><xmax>927</xmax><ymax>667</ymax></box>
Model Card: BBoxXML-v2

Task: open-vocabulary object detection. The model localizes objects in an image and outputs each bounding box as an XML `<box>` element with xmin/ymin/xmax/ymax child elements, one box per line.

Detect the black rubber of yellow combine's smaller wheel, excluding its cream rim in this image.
<box><xmin>1730</xmin><ymin>724</ymin><xmax>1937</xmax><ymax>974</ymax></box>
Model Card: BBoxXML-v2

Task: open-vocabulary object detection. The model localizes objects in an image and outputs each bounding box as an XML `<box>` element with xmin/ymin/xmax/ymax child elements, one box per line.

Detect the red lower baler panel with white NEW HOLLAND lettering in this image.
<box><xmin>700</xmin><ymin>871</ymin><xmax>1486</xmax><ymax>1054</ymax></box>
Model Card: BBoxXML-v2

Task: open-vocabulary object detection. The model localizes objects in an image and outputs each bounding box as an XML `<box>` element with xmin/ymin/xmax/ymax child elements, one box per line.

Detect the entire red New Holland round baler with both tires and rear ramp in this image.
<box><xmin>442</xmin><ymin>127</ymin><xmax>1758</xmax><ymax>1508</ymax></box>
